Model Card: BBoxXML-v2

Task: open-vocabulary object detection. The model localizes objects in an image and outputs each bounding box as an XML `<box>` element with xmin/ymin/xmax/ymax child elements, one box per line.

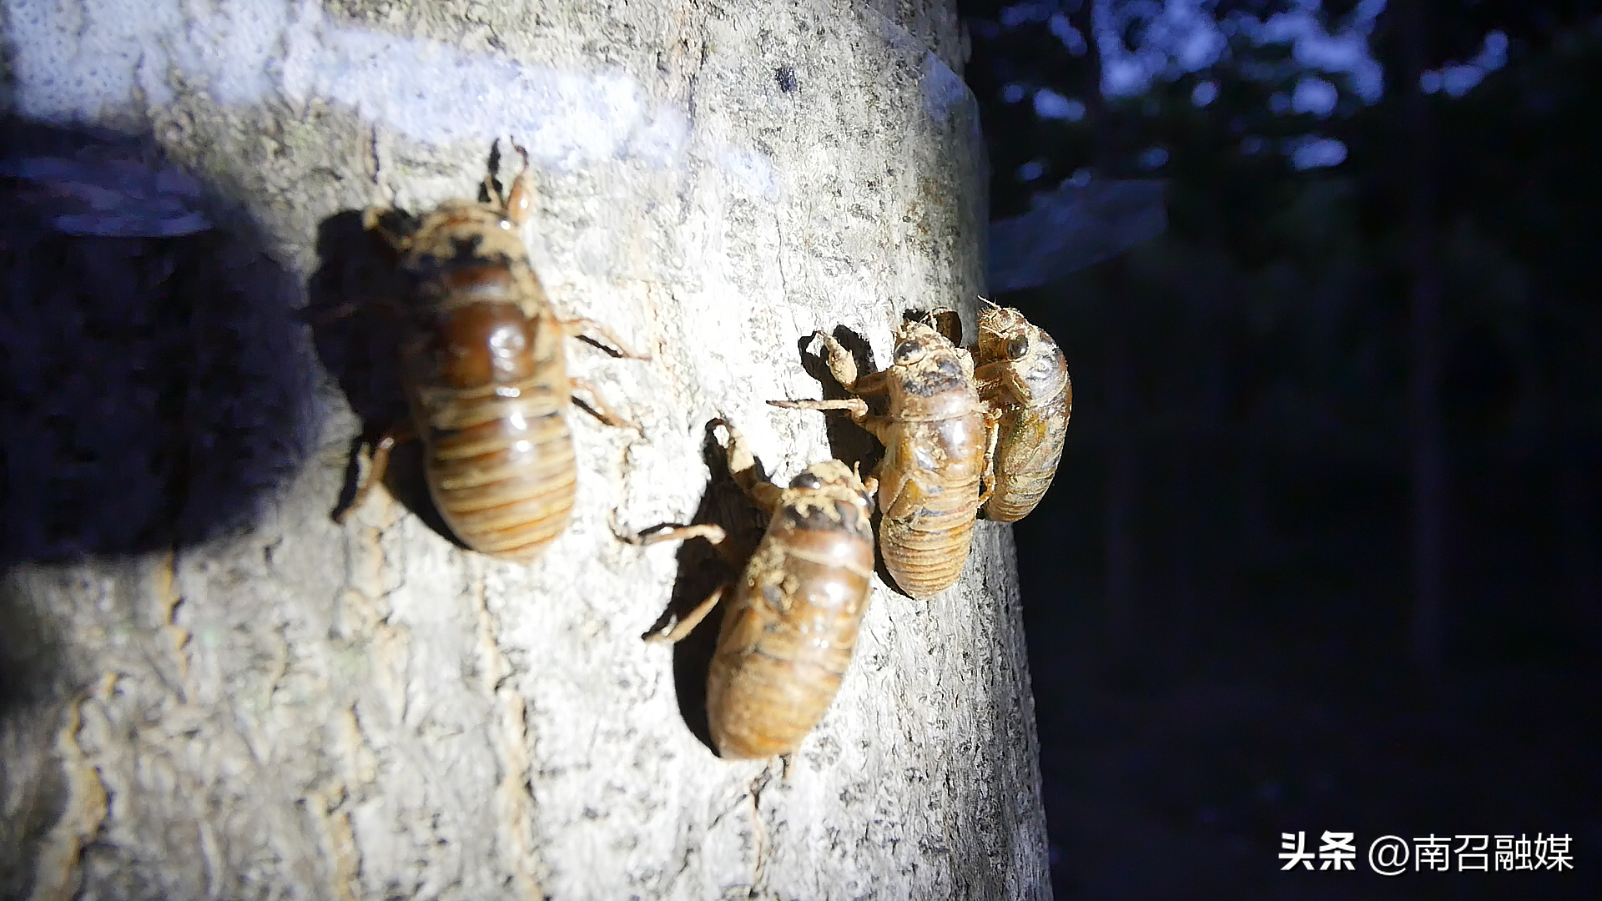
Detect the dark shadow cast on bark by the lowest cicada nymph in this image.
<box><xmin>642</xmin><ymin>420</ymin><xmax>767</xmax><ymax>754</ymax></box>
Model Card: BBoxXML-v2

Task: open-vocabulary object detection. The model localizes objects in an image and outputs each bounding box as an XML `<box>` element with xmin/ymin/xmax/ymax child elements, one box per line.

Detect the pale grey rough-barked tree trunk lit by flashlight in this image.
<box><xmin>0</xmin><ymin>0</ymin><xmax>1051</xmax><ymax>901</ymax></box>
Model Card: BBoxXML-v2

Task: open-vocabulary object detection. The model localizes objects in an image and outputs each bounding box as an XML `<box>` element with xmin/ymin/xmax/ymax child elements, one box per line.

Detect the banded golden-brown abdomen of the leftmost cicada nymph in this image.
<box><xmin>415</xmin><ymin>375</ymin><xmax>575</xmax><ymax>563</ymax></box>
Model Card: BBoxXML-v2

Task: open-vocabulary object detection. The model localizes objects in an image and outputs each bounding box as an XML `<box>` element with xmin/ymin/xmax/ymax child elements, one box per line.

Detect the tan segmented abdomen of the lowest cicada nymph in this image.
<box><xmin>706</xmin><ymin>522</ymin><xmax>873</xmax><ymax>758</ymax></box>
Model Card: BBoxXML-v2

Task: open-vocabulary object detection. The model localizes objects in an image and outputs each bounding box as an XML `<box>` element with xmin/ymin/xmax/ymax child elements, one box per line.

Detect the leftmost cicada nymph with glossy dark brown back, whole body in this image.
<box><xmin>351</xmin><ymin>141</ymin><xmax>639</xmax><ymax>563</ymax></box>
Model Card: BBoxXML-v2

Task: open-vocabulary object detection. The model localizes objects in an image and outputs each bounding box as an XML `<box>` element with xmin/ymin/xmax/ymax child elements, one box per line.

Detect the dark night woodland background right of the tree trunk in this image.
<box><xmin>961</xmin><ymin>0</ymin><xmax>1602</xmax><ymax>899</ymax></box>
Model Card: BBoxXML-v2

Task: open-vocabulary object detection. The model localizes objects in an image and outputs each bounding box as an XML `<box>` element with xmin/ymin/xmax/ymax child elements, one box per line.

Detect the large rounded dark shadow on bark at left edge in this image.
<box><xmin>0</xmin><ymin>119</ymin><xmax>314</xmax><ymax>564</ymax></box>
